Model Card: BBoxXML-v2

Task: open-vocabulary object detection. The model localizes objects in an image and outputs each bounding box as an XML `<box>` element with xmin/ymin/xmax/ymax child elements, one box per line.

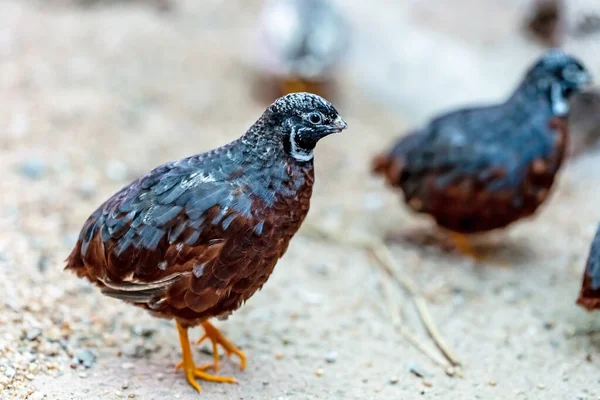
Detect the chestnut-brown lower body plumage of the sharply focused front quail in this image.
<box><xmin>66</xmin><ymin>162</ymin><xmax>314</xmax><ymax>326</ymax></box>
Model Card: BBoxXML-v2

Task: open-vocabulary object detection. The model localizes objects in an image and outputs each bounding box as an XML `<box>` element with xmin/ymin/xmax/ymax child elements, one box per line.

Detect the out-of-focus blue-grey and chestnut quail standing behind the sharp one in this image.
<box><xmin>373</xmin><ymin>50</ymin><xmax>591</xmax><ymax>256</ymax></box>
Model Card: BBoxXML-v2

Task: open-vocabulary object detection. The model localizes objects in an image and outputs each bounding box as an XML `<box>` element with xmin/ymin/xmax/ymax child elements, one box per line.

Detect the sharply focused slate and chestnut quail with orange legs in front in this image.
<box><xmin>66</xmin><ymin>93</ymin><xmax>347</xmax><ymax>390</ymax></box>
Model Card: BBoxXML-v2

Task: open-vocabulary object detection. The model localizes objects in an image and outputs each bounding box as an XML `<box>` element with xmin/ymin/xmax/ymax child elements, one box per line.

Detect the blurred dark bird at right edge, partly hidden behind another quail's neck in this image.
<box><xmin>569</xmin><ymin>88</ymin><xmax>600</xmax><ymax>156</ymax></box>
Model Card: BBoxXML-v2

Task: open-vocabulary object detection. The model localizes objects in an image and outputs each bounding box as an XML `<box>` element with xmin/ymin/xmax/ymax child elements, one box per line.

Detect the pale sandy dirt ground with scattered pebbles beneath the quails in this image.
<box><xmin>0</xmin><ymin>0</ymin><xmax>600</xmax><ymax>400</ymax></box>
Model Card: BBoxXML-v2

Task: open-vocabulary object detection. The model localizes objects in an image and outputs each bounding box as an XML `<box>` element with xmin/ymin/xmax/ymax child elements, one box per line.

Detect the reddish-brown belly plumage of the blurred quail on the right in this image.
<box><xmin>373</xmin><ymin>118</ymin><xmax>568</xmax><ymax>233</ymax></box>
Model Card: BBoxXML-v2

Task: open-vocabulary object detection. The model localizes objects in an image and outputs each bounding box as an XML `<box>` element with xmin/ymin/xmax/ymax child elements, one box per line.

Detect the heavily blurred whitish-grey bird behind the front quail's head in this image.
<box><xmin>258</xmin><ymin>0</ymin><xmax>349</xmax><ymax>99</ymax></box>
